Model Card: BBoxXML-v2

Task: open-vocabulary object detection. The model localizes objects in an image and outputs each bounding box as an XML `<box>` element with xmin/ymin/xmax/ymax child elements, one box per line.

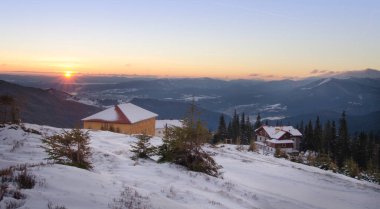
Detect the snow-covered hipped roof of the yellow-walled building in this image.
<box><xmin>82</xmin><ymin>103</ymin><xmax>158</xmax><ymax>123</ymax></box>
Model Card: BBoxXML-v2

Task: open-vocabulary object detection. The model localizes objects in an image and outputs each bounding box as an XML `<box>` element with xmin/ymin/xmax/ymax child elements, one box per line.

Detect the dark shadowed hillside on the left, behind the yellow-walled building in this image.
<box><xmin>0</xmin><ymin>80</ymin><xmax>101</xmax><ymax>128</ymax></box>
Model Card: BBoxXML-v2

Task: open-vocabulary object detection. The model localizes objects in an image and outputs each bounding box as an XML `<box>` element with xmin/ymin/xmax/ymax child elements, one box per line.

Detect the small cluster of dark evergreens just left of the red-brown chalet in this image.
<box><xmin>213</xmin><ymin>110</ymin><xmax>262</xmax><ymax>145</ymax></box>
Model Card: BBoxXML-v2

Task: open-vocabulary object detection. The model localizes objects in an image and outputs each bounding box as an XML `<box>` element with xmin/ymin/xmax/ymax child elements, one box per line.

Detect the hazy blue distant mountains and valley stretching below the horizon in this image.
<box><xmin>0</xmin><ymin>69</ymin><xmax>380</xmax><ymax>131</ymax></box>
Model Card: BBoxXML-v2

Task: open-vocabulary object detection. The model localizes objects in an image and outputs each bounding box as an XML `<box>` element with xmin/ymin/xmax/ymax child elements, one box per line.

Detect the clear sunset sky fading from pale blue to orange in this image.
<box><xmin>0</xmin><ymin>0</ymin><xmax>380</xmax><ymax>79</ymax></box>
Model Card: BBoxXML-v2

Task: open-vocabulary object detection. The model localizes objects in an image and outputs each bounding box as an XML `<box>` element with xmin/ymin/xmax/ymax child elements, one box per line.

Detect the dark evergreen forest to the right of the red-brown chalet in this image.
<box><xmin>296</xmin><ymin>112</ymin><xmax>380</xmax><ymax>173</ymax></box>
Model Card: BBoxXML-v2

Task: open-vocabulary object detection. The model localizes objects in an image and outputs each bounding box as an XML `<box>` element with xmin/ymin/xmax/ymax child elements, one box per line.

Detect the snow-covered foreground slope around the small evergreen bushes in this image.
<box><xmin>0</xmin><ymin>124</ymin><xmax>380</xmax><ymax>209</ymax></box>
